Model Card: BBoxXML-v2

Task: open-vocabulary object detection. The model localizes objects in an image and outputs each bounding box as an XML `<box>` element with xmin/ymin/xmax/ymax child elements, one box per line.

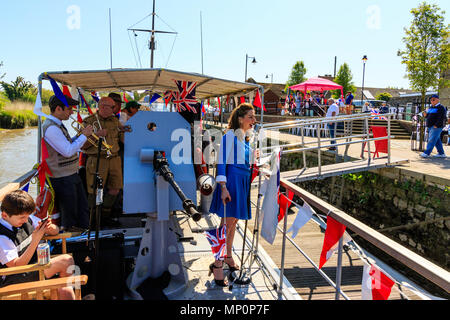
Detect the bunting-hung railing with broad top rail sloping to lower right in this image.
<box><xmin>268</xmin><ymin>179</ymin><xmax>450</xmax><ymax>300</ymax></box>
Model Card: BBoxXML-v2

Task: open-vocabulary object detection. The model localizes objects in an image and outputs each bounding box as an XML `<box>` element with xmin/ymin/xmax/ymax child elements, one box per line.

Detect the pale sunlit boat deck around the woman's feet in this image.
<box><xmin>171</xmin><ymin>214</ymin><xmax>300</xmax><ymax>300</ymax></box>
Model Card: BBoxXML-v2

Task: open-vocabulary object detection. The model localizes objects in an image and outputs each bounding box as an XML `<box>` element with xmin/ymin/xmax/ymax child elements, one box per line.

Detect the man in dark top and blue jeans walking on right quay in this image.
<box><xmin>420</xmin><ymin>94</ymin><xmax>447</xmax><ymax>158</ymax></box>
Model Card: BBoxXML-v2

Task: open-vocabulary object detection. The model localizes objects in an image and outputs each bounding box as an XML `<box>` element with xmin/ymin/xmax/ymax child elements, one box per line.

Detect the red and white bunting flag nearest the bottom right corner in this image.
<box><xmin>361</xmin><ymin>263</ymin><xmax>395</xmax><ymax>300</ymax></box>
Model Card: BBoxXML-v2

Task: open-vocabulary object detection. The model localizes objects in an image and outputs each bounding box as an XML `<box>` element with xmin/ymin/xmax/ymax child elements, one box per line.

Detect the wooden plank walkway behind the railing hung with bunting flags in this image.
<box><xmin>243</xmin><ymin>188</ymin><xmax>419</xmax><ymax>300</ymax></box>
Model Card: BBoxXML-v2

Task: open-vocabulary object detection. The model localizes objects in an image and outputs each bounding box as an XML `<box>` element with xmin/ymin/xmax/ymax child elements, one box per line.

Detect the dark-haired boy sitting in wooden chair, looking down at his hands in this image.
<box><xmin>0</xmin><ymin>190</ymin><xmax>75</xmax><ymax>300</ymax></box>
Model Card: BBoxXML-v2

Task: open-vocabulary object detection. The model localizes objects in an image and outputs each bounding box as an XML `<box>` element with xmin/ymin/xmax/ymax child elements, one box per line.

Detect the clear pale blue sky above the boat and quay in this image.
<box><xmin>0</xmin><ymin>0</ymin><xmax>450</xmax><ymax>88</ymax></box>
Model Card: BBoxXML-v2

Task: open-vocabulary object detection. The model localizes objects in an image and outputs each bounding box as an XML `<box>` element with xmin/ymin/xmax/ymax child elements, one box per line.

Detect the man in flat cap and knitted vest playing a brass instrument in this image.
<box><xmin>42</xmin><ymin>96</ymin><xmax>93</xmax><ymax>232</ymax></box>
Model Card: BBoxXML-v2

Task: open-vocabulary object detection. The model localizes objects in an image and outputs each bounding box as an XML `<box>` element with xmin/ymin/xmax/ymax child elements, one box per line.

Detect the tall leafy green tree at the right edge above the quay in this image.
<box><xmin>398</xmin><ymin>2</ymin><xmax>450</xmax><ymax>150</ymax></box>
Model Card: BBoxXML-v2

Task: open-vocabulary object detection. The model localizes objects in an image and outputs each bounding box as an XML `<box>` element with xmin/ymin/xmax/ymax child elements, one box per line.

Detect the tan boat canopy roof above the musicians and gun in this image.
<box><xmin>40</xmin><ymin>69</ymin><xmax>261</xmax><ymax>99</ymax></box>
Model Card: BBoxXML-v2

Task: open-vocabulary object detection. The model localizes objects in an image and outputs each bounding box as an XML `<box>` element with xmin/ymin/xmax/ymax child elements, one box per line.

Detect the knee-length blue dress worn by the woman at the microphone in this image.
<box><xmin>209</xmin><ymin>134</ymin><xmax>251</xmax><ymax>220</ymax></box>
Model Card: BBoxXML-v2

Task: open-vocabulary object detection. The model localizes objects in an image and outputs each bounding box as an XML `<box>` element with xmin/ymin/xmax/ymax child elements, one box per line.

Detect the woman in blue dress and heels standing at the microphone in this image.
<box><xmin>209</xmin><ymin>103</ymin><xmax>258</xmax><ymax>286</ymax></box>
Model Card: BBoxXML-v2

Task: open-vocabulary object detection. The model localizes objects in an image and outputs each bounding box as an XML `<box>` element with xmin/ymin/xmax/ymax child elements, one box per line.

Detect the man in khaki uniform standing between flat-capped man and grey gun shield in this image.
<box><xmin>83</xmin><ymin>97</ymin><xmax>124</xmax><ymax>225</ymax></box>
